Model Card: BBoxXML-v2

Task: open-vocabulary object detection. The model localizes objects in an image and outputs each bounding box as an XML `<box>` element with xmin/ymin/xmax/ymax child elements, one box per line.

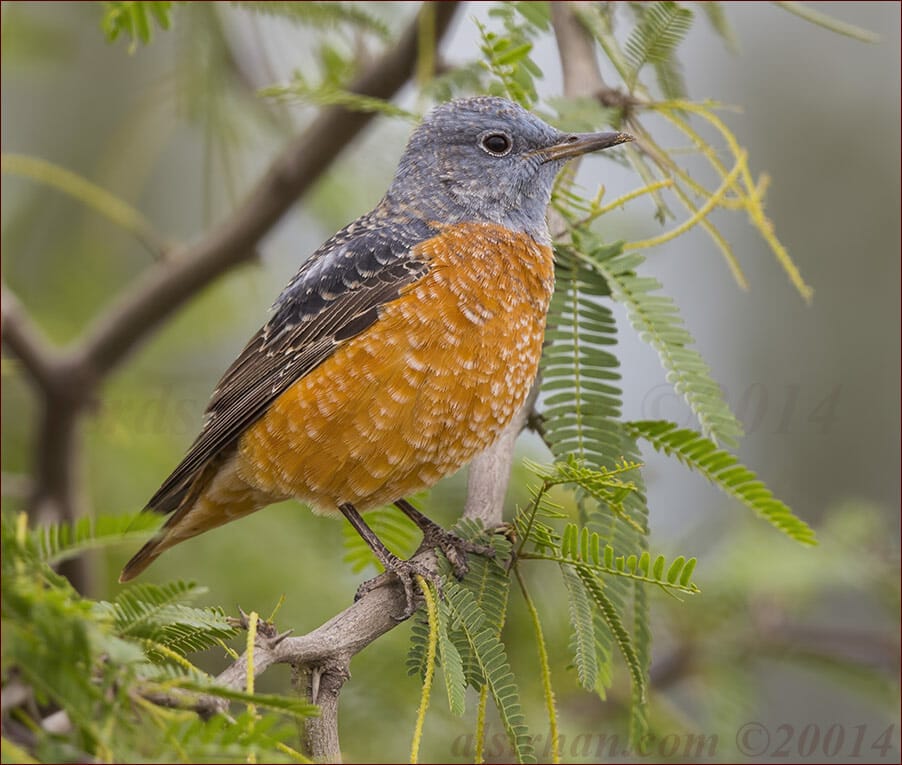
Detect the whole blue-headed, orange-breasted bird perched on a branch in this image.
<box><xmin>119</xmin><ymin>96</ymin><xmax>633</xmax><ymax>617</ymax></box>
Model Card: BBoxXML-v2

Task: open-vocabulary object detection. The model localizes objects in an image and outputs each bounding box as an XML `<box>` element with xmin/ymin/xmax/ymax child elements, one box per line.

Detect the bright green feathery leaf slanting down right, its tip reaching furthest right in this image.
<box><xmin>625</xmin><ymin>420</ymin><xmax>817</xmax><ymax>545</ymax></box>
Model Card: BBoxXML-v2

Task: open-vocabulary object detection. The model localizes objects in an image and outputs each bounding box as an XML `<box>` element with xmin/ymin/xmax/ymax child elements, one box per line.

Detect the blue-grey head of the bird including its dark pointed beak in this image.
<box><xmin>385</xmin><ymin>96</ymin><xmax>632</xmax><ymax>240</ymax></box>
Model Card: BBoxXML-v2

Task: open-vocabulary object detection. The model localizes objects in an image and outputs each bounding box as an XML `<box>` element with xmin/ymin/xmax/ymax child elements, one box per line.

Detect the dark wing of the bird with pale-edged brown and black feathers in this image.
<box><xmin>147</xmin><ymin>212</ymin><xmax>436</xmax><ymax>514</ymax></box>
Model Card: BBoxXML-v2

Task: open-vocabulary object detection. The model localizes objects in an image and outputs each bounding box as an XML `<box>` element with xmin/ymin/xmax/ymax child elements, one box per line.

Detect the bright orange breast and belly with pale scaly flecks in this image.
<box><xmin>237</xmin><ymin>223</ymin><xmax>554</xmax><ymax>511</ymax></box>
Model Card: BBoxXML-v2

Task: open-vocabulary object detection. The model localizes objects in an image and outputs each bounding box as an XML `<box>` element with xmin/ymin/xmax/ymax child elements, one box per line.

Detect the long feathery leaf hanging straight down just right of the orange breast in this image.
<box><xmin>542</xmin><ymin>234</ymin><xmax>650</xmax><ymax>743</ymax></box>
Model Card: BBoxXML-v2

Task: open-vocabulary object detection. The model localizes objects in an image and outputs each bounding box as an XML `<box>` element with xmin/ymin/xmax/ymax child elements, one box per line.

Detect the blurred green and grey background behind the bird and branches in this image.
<box><xmin>2</xmin><ymin>2</ymin><xmax>900</xmax><ymax>761</ymax></box>
